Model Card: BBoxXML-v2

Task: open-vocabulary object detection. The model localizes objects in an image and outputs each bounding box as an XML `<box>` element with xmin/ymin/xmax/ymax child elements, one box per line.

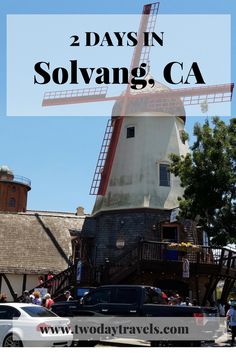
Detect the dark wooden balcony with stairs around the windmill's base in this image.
<box><xmin>103</xmin><ymin>240</ymin><xmax>236</xmax><ymax>283</ymax></box>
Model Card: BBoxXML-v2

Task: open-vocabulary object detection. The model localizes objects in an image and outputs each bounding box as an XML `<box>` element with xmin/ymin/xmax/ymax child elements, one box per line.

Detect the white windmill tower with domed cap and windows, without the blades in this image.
<box><xmin>93</xmin><ymin>78</ymin><xmax>188</xmax><ymax>214</ymax></box>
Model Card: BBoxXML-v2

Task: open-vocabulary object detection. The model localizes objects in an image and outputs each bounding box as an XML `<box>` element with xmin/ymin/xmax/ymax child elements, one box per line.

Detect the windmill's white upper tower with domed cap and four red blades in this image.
<box><xmin>42</xmin><ymin>2</ymin><xmax>234</xmax><ymax>212</ymax></box>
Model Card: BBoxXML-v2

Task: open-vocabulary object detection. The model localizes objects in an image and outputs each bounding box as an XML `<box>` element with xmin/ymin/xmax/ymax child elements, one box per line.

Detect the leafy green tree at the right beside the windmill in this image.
<box><xmin>170</xmin><ymin>117</ymin><xmax>236</xmax><ymax>245</ymax></box>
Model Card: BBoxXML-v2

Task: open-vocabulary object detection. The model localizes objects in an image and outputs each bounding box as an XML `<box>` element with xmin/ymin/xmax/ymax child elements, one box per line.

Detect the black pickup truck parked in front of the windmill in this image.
<box><xmin>52</xmin><ymin>285</ymin><xmax>219</xmax><ymax>346</ymax></box>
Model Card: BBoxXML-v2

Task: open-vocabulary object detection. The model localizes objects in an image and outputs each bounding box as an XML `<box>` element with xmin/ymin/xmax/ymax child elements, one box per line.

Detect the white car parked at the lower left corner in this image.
<box><xmin>0</xmin><ymin>303</ymin><xmax>73</xmax><ymax>347</ymax></box>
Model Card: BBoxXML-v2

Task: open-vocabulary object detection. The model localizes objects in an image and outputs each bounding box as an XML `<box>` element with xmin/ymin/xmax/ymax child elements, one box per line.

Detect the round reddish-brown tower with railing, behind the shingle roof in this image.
<box><xmin>0</xmin><ymin>165</ymin><xmax>31</xmax><ymax>212</ymax></box>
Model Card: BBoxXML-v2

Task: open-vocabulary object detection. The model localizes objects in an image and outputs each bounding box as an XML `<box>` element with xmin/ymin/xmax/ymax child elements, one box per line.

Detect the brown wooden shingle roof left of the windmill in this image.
<box><xmin>0</xmin><ymin>212</ymin><xmax>85</xmax><ymax>274</ymax></box>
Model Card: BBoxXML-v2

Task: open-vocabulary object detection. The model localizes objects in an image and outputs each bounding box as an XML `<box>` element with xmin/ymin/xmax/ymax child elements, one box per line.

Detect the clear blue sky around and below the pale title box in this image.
<box><xmin>0</xmin><ymin>0</ymin><xmax>236</xmax><ymax>213</ymax></box>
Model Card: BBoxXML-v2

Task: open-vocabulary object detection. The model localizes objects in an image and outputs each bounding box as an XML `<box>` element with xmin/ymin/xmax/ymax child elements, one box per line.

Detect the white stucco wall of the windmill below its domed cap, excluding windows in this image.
<box><xmin>93</xmin><ymin>113</ymin><xmax>188</xmax><ymax>213</ymax></box>
